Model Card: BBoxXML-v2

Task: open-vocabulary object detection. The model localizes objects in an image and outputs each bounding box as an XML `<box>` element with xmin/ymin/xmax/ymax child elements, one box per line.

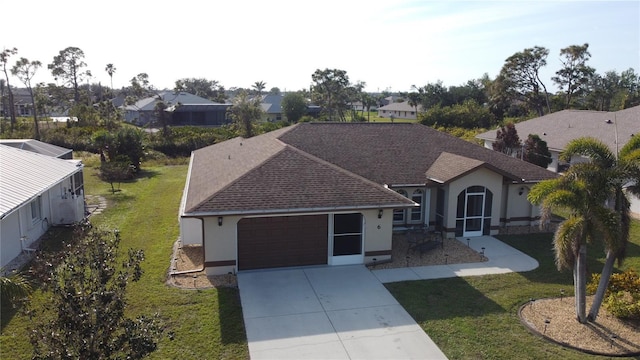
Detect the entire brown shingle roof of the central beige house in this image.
<box><xmin>183</xmin><ymin>123</ymin><xmax>556</xmax><ymax>214</ymax></box>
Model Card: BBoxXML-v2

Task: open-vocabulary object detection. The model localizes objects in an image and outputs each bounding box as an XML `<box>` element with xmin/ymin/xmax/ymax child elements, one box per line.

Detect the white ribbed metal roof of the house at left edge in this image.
<box><xmin>0</xmin><ymin>145</ymin><xmax>82</xmax><ymax>219</ymax></box>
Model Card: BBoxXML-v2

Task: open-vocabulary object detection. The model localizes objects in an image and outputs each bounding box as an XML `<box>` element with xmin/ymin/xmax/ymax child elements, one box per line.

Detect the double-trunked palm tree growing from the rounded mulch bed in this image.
<box><xmin>528</xmin><ymin>138</ymin><xmax>640</xmax><ymax>323</ymax></box>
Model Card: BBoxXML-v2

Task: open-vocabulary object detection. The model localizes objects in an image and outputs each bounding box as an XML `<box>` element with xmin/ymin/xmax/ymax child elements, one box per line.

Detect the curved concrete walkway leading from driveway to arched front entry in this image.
<box><xmin>371</xmin><ymin>236</ymin><xmax>539</xmax><ymax>283</ymax></box>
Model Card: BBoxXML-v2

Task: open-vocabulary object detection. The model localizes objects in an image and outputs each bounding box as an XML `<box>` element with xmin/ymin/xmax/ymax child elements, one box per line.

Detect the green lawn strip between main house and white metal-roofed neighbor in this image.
<box><xmin>0</xmin><ymin>161</ymin><xmax>249</xmax><ymax>359</ymax></box>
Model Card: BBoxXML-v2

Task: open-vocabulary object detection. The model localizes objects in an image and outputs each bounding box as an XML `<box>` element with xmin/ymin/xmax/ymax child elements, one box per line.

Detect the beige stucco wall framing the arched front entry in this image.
<box><xmin>445</xmin><ymin>168</ymin><xmax>502</xmax><ymax>236</ymax></box>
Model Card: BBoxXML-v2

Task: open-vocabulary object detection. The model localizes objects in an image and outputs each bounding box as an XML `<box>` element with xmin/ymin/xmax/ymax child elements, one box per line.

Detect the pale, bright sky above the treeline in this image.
<box><xmin>0</xmin><ymin>0</ymin><xmax>640</xmax><ymax>91</ymax></box>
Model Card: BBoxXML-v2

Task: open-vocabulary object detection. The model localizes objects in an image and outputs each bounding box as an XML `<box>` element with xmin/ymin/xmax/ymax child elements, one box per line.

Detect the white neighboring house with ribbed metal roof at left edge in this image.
<box><xmin>0</xmin><ymin>144</ymin><xmax>85</xmax><ymax>270</ymax></box>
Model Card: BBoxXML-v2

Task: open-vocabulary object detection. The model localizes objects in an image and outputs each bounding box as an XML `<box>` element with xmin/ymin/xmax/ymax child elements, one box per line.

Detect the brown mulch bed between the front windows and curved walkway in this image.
<box><xmin>368</xmin><ymin>234</ymin><xmax>488</xmax><ymax>270</ymax></box>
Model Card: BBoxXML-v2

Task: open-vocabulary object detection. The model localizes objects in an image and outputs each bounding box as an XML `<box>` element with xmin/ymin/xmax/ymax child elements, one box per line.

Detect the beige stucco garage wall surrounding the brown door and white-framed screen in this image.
<box><xmin>198</xmin><ymin>209</ymin><xmax>393</xmax><ymax>275</ymax></box>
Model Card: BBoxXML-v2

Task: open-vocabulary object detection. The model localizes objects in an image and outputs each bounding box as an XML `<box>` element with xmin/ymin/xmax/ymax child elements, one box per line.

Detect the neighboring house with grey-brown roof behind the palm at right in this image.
<box><xmin>476</xmin><ymin>106</ymin><xmax>640</xmax><ymax>172</ymax></box>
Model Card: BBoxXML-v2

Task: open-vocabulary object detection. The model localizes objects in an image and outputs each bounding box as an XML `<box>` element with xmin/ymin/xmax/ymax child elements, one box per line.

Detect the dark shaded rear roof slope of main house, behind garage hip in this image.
<box><xmin>280</xmin><ymin>123</ymin><xmax>555</xmax><ymax>186</ymax></box>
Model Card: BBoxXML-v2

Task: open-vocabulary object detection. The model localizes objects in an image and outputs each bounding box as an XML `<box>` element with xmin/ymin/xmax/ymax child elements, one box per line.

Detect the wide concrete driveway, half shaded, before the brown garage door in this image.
<box><xmin>238</xmin><ymin>265</ymin><xmax>446</xmax><ymax>360</ymax></box>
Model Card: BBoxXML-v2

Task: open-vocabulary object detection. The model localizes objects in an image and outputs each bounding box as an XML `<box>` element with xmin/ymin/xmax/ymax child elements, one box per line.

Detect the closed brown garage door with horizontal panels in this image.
<box><xmin>238</xmin><ymin>215</ymin><xmax>328</xmax><ymax>270</ymax></box>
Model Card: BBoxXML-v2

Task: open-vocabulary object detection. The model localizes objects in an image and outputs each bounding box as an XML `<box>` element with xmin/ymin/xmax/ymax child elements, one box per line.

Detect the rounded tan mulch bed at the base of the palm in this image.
<box><xmin>520</xmin><ymin>296</ymin><xmax>640</xmax><ymax>356</ymax></box>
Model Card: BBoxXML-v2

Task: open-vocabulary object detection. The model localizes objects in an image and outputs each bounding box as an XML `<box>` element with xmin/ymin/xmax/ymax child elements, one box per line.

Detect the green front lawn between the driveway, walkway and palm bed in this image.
<box><xmin>386</xmin><ymin>231</ymin><xmax>640</xmax><ymax>359</ymax></box>
